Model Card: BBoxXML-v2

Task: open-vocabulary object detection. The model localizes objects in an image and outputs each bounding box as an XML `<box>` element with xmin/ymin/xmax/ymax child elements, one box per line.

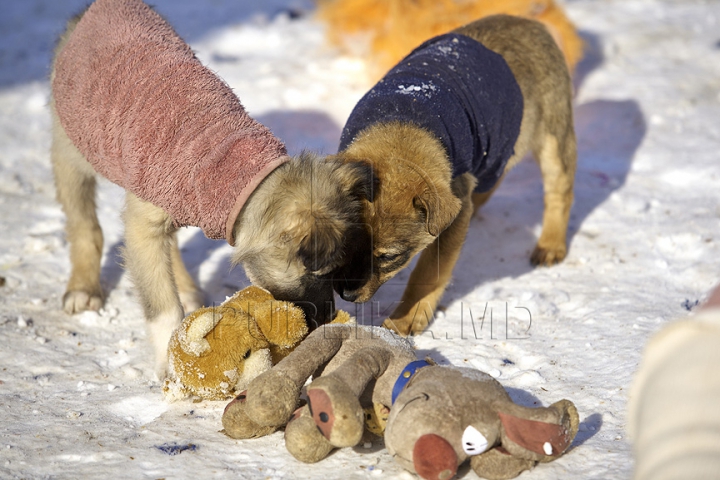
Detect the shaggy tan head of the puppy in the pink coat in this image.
<box><xmin>233</xmin><ymin>153</ymin><xmax>373</xmax><ymax>329</ymax></box>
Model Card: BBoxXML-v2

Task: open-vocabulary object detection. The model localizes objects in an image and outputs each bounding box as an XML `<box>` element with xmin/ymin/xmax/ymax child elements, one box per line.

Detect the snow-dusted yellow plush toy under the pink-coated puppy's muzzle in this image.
<box><xmin>163</xmin><ymin>286</ymin><xmax>349</xmax><ymax>401</ymax></box>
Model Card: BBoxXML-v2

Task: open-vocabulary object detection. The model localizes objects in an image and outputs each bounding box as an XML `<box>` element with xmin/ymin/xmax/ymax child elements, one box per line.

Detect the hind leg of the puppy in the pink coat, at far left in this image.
<box><xmin>50</xmin><ymin>107</ymin><xmax>103</xmax><ymax>313</ymax></box>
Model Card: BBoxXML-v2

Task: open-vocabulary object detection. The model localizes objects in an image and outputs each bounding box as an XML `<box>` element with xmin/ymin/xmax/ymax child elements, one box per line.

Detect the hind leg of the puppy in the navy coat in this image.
<box><xmin>530</xmin><ymin>126</ymin><xmax>577</xmax><ymax>265</ymax></box>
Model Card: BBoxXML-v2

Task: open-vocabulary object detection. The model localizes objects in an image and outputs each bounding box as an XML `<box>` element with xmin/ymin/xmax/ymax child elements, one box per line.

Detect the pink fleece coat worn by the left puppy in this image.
<box><xmin>52</xmin><ymin>0</ymin><xmax>288</xmax><ymax>244</ymax></box>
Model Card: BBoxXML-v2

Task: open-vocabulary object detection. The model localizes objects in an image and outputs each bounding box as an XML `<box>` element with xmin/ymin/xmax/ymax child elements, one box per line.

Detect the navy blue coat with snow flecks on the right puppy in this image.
<box><xmin>340</xmin><ymin>34</ymin><xmax>523</xmax><ymax>192</ymax></box>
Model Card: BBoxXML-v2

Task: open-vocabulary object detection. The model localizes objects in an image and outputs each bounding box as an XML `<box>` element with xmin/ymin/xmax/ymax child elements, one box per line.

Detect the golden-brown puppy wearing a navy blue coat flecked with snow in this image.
<box><xmin>334</xmin><ymin>15</ymin><xmax>577</xmax><ymax>335</ymax></box>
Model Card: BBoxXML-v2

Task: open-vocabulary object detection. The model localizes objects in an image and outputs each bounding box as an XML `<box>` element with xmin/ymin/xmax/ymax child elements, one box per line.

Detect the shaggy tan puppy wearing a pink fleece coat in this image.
<box><xmin>51</xmin><ymin>0</ymin><xmax>370</xmax><ymax>373</ymax></box>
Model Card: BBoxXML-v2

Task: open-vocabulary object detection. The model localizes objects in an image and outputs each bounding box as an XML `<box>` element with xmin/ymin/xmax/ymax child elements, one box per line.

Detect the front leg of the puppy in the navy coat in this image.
<box><xmin>383</xmin><ymin>173</ymin><xmax>475</xmax><ymax>336</ymax></box>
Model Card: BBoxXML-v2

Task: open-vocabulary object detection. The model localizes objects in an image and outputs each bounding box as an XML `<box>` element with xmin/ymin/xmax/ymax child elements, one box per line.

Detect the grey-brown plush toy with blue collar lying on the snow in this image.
<box><xmin>223</xmin><ymin>324</ymin><xmax>579</xmax><ymax>480</ymax></box>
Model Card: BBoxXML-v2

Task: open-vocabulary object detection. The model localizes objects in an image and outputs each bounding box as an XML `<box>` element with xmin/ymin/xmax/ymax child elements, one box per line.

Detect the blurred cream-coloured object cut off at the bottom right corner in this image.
<box><xmin>628</xmin><ymin>287</ymin><xmax>720</xmax><ymax>480</ymax></box>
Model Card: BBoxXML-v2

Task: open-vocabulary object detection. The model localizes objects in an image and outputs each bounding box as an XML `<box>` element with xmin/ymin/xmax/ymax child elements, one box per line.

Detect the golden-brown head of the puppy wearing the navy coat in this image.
<box><xmin>334</xmin><ymin>123</ymin><xmax>461</xmax><ymax>302</ymax></box>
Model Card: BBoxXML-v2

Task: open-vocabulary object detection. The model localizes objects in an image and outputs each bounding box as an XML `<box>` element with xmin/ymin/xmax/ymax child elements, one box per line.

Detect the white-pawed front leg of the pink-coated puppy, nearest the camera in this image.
<box><xmin>123</xmin><ymin>192</ymin><xmax>183</xmax><ymax>378</ymax></box>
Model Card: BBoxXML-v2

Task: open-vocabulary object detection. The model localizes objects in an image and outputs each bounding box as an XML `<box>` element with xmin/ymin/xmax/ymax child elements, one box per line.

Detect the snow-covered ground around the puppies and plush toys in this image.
<box><xmin>0</xmin><ymin>0</ymin><xmax>720</xmax><ymax>479</ymax></box>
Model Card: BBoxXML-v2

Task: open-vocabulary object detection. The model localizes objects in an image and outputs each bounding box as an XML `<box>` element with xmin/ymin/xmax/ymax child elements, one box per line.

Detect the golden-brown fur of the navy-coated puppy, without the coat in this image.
<box><xmin>335</xmin><ymin>15</ymin><xmax>577</xmax><ymax>335</ymax></box>
